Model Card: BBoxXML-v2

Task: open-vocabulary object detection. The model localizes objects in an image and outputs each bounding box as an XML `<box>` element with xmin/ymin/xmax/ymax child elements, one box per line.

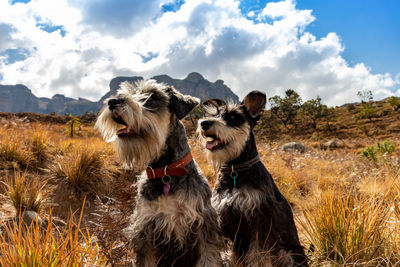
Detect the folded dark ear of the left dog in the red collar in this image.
<box><xmin>166</xmin><ymin>86</ymin><xmax>200</xmax><ymax>120</ymax></box>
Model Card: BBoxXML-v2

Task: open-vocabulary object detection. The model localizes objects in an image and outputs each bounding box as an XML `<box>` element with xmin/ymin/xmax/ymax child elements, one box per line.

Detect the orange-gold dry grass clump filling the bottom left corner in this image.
<box><xmin>0</xmin><ymin>205</ymin><xmax>106</xmax><ymax>266</ymax></box>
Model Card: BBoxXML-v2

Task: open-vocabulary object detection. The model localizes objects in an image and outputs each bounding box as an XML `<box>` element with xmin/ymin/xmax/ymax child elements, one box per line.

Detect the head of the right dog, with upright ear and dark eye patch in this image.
<box><xmin>197</xmin><ymin>91</ymin><xmax>266</xmax><ymax>166</ymax></box>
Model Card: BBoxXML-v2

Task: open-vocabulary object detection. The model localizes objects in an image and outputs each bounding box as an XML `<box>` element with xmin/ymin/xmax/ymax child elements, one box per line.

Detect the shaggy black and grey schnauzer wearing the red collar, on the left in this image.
<box><xmin>96</xmin><ymin>80</ymin><xmax>222</xmax><ymax>266</ymax></box>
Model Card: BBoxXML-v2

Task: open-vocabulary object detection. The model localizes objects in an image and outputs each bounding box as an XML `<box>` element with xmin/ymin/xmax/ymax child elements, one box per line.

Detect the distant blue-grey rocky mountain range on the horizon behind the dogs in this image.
<box><xmin>0</xmin><ymin>72</ymin><xmax>239</xmax><ymax>115</ymax></box>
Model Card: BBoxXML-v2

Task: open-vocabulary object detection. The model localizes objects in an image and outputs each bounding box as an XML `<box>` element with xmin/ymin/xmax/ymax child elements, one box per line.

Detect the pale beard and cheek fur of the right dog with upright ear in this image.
<box><xmin>198</xmin><ymin>120</ymin><xmax>250</xmax><ymax>170</ymax></box>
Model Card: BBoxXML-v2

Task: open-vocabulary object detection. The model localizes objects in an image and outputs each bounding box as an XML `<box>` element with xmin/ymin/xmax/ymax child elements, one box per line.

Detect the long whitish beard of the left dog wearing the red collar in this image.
<box><xmin>96</xmin><ymin>103</ymin><xmax>170</xmax><ymax>171</ymax></box>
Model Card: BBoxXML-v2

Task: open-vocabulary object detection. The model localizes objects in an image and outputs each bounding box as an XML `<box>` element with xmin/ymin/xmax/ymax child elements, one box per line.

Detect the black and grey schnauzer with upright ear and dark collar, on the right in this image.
<box><xmin>198</xmin><ymin>91</ymin><xmax>308</xmax><ymax>266</ymax></box>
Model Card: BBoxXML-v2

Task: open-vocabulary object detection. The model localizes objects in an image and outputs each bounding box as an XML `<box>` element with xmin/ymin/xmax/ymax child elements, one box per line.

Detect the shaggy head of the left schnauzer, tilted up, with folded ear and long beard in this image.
<box><xmin>95</xmin><ymin>80</ymin><xmax>199</xmax><ymax>169</ymax></box>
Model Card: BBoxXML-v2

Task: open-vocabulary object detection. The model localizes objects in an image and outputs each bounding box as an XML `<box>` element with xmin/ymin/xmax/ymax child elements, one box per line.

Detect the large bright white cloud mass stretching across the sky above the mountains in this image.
<box><xmin>0</xmin><ymin>0</ymin><xmax>400</xmax><ymax>105</ymax></box>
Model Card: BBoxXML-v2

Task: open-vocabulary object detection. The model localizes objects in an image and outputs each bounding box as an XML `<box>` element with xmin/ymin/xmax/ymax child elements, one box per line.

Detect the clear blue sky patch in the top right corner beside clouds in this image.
<box><xmin>297</xmin><ymin>0</ymin><xmax>400</xmax><ymax>75</ymax></box>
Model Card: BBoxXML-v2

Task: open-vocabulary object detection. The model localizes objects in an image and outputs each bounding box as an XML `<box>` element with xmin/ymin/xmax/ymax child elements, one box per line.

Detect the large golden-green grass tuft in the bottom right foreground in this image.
<box><xmin>300</xmin><ymin>189</ymin><xmax>391</xmax><ymax>266</ymax></box>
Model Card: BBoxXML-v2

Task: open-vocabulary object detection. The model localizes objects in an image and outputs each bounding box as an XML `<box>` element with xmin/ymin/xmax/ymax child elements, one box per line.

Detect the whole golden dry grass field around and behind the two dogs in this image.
<box><xmin>0</xmin><ymin>102</ymin><xmax>400</xmax><ymax>266</ymax></box>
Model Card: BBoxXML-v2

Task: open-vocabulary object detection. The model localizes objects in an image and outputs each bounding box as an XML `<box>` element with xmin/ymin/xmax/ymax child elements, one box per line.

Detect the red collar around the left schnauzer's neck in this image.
<box><xmin>146</xmin><ymin>151</ymin><xmax>193</xmax><ymax>179</ymax></box>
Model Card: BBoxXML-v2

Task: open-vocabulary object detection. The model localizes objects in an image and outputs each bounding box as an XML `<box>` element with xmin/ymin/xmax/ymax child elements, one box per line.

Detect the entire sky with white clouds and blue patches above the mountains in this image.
<box><xmin>0</xmin><ymin>0</ymin><xmax>400</xmax><ymax>106</ymax></box>
